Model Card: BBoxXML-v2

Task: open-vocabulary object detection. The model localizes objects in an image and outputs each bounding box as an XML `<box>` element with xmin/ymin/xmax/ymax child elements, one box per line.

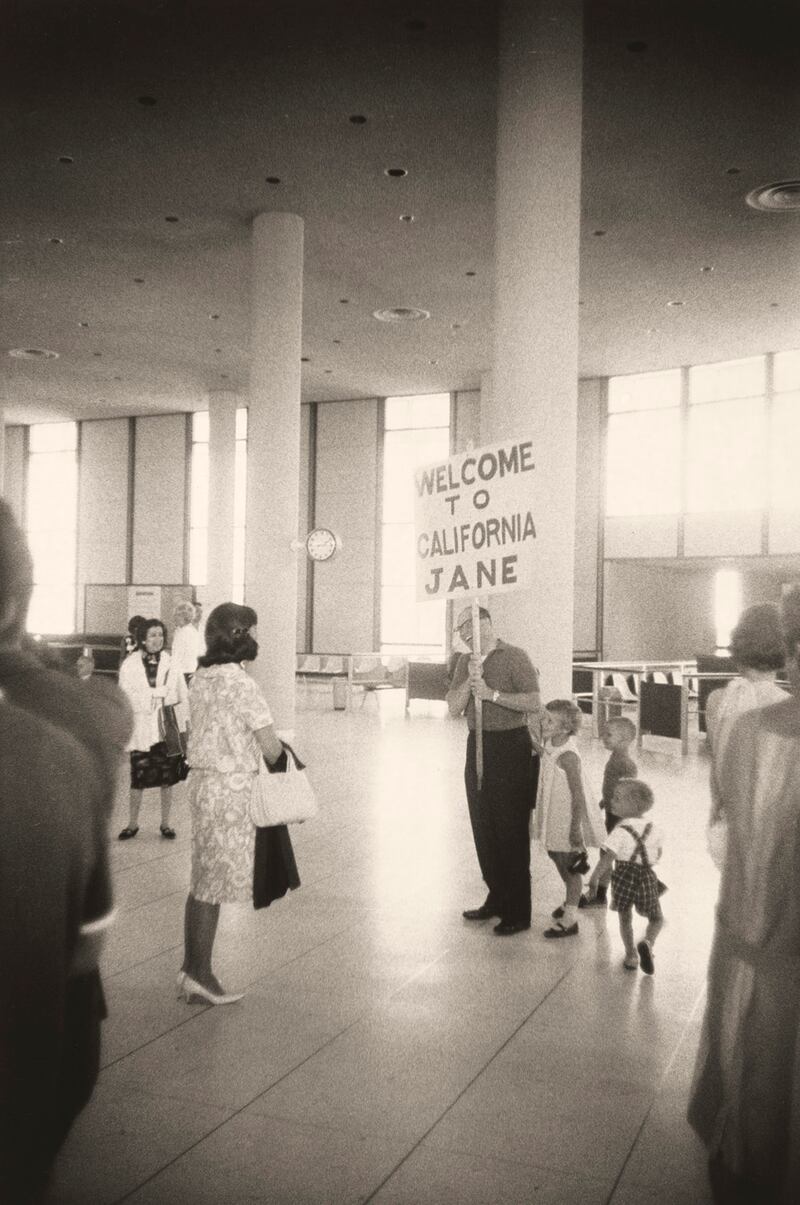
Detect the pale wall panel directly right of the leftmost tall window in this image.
<box><xmin>77</xmin><ymin>418</ymin><xmax>130</xmax><ymax>625</ymax></box>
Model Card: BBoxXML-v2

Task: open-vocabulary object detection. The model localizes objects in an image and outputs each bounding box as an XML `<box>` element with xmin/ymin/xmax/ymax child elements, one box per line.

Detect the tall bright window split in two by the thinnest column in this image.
<box><xmin>189</xmin><ymin>406</ymin><xmax>247</xmax><ymax>603</ymax></box>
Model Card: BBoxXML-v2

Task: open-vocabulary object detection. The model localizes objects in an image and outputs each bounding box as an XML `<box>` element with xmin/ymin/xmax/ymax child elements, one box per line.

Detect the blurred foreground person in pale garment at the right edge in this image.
<box><xmin>689</xmin><ymin>587</ymin><xmax>800</xmax><ymax>1205</ymax></box>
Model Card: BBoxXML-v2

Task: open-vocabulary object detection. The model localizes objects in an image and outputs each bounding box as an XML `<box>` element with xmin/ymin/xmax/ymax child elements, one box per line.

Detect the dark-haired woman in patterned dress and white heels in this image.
<box><xmin>178</xmin><ymin>603</ymin><xmax>283</xmax><ymax>1004</ymax></box>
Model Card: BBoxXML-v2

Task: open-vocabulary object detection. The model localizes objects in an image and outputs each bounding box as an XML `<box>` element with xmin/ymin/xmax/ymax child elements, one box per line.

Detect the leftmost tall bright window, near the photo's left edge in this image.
<box><xmin>25</xmin><ymin>423</ymin><xmax>78</xmax><ymax>635</ymax></box>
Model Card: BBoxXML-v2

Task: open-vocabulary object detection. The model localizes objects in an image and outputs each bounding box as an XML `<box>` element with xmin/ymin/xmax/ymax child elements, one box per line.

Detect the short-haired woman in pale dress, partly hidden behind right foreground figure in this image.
<box><xmin>706</xmin><ymin>603</ymin><xmax>786</xmax><ymax>869</ymax></box>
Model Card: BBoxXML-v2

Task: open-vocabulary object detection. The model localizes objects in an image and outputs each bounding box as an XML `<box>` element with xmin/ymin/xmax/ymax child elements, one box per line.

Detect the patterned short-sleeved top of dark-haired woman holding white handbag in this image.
<box><xmin>187</xmin><ymin>664</ymin><xmax>272</xmax><ymax>774</ymax></box>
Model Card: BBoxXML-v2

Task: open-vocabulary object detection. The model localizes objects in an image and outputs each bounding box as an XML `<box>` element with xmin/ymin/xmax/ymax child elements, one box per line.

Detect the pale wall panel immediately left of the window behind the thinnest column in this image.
<box><xmin>133</xmin><ymin>415</ymin><xmax>188</xmax><ymax>586</ymax></box>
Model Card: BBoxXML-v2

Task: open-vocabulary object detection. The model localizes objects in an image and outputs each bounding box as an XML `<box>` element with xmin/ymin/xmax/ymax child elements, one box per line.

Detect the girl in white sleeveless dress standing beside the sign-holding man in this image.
<box><xmin>534</xmin><ymin>699</ymin><xmax>602</xmax><ymax>937</ymax></box>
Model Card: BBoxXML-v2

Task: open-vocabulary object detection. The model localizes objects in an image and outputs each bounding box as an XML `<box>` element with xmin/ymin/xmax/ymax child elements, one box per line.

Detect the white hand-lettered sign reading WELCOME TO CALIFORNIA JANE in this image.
<box><xmin>414</xmin><ymin>440</ymin><xmax>536</xmax><ymax>603</ymax></box>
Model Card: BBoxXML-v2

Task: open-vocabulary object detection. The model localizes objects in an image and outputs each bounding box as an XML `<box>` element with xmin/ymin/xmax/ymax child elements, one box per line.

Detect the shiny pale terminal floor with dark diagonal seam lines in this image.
<box><xmin>47</xmin><ymin>689</ymin><xmax>718</xmax><ymax>1205</ymax></box>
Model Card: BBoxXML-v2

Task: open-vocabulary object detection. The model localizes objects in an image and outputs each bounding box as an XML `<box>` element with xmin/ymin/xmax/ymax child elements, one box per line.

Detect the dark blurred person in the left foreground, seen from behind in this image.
<box><xmin>0</xmin><ymin>500</ymin><xmax>130</xmax><ymax>1203</ymax></box>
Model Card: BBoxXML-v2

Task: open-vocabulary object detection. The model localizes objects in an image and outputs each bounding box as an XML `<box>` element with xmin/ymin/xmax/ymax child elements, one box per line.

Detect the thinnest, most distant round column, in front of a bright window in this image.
<box><xmin>202</xmin><ymin>390</ymin><xmax>239</xmax><ymax>619</ymax></box>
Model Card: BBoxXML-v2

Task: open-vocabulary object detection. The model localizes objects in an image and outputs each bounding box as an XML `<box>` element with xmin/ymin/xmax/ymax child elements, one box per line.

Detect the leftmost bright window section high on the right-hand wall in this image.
<box><xmin>606</xmin><ymin>369</ymin><xmax>681</xmax><ymax>516</ymax></box>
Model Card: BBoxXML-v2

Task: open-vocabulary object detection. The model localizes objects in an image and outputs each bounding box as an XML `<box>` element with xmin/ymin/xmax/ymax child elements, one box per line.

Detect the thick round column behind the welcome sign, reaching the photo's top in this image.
<box><xmin>481</xmin><ymin>0</ymin><xmax>582</xmax><ymax>698</ymax></box>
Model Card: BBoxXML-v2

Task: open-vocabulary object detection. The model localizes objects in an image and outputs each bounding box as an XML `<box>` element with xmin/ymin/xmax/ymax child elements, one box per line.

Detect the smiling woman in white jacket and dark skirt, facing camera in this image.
<box><xmin>119</xmin><ymin>619</ymin><xmax>188</xmax><ymax>841</ymax></box>
